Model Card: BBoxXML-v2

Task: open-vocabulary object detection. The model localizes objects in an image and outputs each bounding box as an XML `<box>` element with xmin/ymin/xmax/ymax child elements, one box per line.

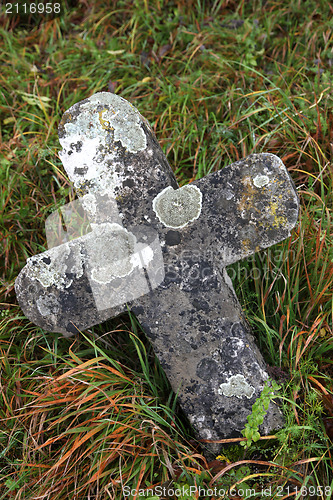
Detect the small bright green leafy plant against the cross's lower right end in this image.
<box><xmin>240</xmin><ymin>380</ymin><xmax>281</xmax><ymax>449</ymax></box>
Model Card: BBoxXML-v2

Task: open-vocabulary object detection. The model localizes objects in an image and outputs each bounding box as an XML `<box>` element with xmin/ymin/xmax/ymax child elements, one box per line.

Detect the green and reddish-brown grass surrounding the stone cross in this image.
<box><xmin>0</xmin><ymin>0</ymin><xmax>333</xmax><ymax>500</ymax></box>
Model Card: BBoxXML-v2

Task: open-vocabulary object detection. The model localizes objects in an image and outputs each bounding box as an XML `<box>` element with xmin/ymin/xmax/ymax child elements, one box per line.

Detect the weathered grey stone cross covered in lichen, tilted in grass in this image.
<box><xmin>15</xmin><ymin>92</ymin><xmax>299</xmax><ymax>451</ymax></box>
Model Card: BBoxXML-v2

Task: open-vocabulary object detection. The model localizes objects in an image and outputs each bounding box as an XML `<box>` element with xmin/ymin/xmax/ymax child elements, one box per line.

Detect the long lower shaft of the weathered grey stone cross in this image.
<box><xmin>132</xmin><ymin>268</ymin><xmax>283</xmax><ymax>458</ymax></box>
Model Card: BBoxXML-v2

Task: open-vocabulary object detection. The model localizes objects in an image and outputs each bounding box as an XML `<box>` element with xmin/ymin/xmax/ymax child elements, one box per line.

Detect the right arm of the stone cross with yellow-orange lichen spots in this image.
<box><xmin>191</xmin><ymin>153</ymin><xmax>299</xmax><ymax>266</ymax></box>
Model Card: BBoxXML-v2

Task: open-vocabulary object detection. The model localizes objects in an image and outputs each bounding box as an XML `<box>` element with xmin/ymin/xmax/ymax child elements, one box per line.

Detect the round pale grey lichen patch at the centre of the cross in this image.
<box><xmin>153</xmin><ymin>185</ymin><xmax>202</xmax><ymax>229</ymax></box>
